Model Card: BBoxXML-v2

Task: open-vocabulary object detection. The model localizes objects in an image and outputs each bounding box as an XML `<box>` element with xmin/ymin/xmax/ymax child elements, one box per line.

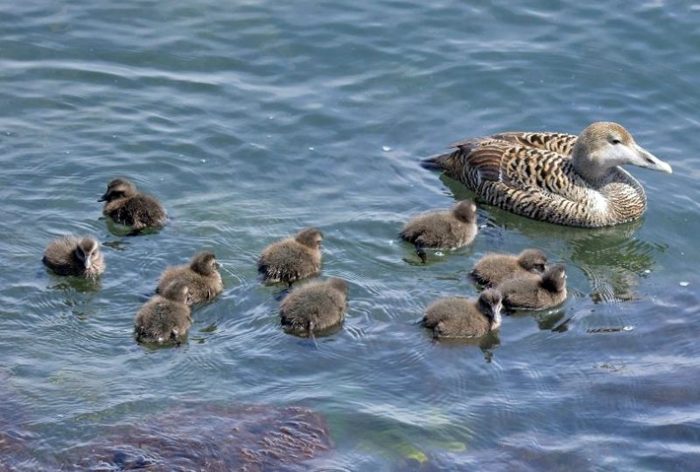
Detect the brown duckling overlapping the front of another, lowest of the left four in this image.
<box><xmin>134</xmin><ymin>280</ymin><xmax>192</xmax><ymax>344</ymax></box>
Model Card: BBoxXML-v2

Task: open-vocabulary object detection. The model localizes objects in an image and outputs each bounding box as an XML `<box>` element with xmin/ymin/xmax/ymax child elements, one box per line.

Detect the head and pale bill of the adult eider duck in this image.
<box><xmin>573</xmin><ymin>121</ymin><xmax>672</xmax><ymax>180</ymax></box>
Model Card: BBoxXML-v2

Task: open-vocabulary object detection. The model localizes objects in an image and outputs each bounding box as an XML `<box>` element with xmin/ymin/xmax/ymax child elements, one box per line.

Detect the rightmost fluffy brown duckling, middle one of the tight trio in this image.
<box><xmin>497</xmin><ymin>264</ymin><xmax>566</xmax><ymax>310</ymax></box>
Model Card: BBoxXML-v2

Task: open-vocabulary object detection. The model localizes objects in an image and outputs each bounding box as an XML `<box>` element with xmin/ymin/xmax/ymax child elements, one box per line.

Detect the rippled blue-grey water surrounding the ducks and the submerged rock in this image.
<box><xmin>0</xmin><ymin>0</ymin><xmax>700</xmax><ymax>471</ymax></box>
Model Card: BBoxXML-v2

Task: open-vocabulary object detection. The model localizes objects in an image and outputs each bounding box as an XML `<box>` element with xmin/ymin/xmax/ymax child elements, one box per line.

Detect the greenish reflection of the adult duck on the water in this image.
<box><xmin>440</xmin><ymin>175</ymin><xmax>667</xmax><ymax>303</ymax></box>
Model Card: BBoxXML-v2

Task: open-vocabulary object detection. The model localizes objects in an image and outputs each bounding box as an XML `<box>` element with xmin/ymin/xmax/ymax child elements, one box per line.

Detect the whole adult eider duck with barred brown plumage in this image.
<box><xmin>423</xmin><ymin>122</ymin><xmax>671</xmax><ymax>228</ymax></box>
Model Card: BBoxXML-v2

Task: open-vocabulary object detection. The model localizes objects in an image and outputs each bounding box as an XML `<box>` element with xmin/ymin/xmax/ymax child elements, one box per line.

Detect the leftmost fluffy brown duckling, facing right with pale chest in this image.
<box><xmin>42</xmin><ymin>236</ymin><xmax>105</xmax><ymax>278</ymax></box>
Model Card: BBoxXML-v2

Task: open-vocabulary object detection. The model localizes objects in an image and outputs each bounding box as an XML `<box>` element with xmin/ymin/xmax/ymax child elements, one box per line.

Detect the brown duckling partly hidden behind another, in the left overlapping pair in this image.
<box><xmin>156</xmin><ymin>251</ymin><xmax>224</xmax><ymax>303</ymax></box>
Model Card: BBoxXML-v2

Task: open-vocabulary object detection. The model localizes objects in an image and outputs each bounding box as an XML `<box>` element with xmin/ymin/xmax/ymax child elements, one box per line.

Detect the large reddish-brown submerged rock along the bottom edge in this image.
<box><xmin>61</xmin><ymin>404</ymin><xmax>331</xmax><ymax>471</ymax></box>
